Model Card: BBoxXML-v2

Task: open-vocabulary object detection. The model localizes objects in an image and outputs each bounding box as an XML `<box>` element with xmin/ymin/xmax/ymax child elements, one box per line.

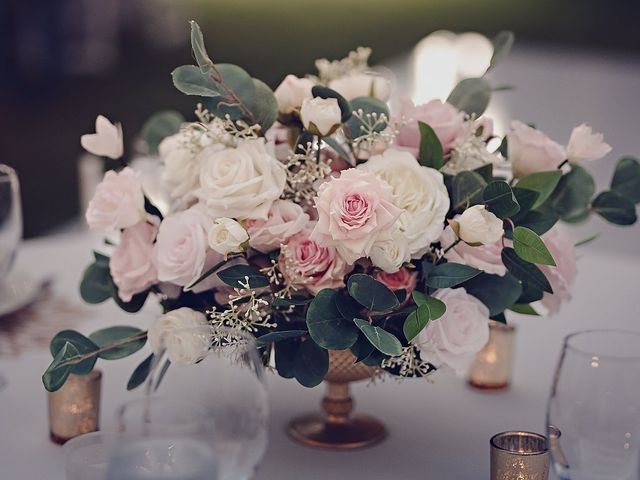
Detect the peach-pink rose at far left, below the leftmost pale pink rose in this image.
<box><xmin>109</xmin><ymin>222</ymin><xmax>158</xmax><ymax>302</ymax></box>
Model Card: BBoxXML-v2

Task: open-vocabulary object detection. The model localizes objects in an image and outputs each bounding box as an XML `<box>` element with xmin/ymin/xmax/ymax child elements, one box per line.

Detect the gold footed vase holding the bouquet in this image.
<box><xmin>287</xmin><ymin>350</ymin><xmax>387</xmax><ymax>450</ymax></box>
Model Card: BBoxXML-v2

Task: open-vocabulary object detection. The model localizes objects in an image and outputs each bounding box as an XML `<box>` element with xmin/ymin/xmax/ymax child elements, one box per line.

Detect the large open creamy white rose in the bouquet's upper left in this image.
<box><xmin>195</xmin><ymin>139</ymin><xmax>287</xmax><ymax>219</ymax></box>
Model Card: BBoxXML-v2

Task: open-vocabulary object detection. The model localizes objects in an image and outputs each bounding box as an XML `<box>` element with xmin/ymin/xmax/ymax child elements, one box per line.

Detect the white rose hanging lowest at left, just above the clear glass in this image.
<box><xmin>147</xmin><ymin>307</ymin><xmax>211</xmax><ymax>365</ymax></box>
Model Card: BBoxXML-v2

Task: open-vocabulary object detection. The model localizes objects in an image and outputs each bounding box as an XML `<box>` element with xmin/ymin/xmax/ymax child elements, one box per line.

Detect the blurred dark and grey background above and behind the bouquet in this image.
<box><xmin>0</xmin><ymin>0</ymin><xmax>640</xmax><ymax>237</ymax></box>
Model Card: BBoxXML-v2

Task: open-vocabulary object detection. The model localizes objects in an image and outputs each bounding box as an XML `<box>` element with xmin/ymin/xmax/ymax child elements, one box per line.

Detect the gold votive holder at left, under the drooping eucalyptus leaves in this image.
<box><xmin>49</xmin><ymin>370</ymin><xmax>102</xmax><ymax>444</ymax></box>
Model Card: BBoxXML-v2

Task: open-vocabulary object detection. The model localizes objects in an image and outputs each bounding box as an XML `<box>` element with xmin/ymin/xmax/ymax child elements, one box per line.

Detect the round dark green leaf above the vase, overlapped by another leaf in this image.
<box><xmin>307</xmin><ymin>288</ymin><xmax>360</xmax><ymax>350</ymax></box>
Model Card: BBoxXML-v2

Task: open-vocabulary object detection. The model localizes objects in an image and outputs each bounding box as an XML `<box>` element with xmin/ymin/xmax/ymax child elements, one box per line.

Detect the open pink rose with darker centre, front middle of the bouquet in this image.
<box><xmin>310</xmin><ymin>168</ymin><xmax>402</xmax><ymax>264</ymax></box>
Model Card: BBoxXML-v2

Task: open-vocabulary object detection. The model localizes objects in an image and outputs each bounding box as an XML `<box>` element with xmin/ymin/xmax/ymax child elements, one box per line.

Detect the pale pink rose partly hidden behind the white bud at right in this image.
<box><xmin>440</xmin><ymin>227</ymin><xmax>507</xmax><ymax>276</ymax></box>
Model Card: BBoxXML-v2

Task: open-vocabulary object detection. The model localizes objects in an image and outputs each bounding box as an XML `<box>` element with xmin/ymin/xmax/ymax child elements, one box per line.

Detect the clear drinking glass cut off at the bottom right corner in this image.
<box><xmin>547</xmin><ymin>330</ymin><xmax>640</xmax><ymax>480</ymax></box>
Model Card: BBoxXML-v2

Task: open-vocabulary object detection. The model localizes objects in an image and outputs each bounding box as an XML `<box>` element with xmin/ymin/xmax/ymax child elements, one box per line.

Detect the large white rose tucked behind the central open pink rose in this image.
<box><xmin>358</xmin><ymin>148</ymin><xmax>449</xmax><ymax>258</ymax></box>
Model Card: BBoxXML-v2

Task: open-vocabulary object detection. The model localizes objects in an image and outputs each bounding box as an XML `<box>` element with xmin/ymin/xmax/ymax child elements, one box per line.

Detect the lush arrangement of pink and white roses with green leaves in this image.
<box><xmin>43</xmin><ymin>22</ymin><xmax>640</xmax><ymax>391</ymax></box>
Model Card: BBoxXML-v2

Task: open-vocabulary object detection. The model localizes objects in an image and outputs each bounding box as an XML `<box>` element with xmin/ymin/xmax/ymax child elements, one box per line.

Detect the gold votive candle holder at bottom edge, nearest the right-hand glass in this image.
<box><xmin>489</xmin><ymin>432</ymin><xmax>549</xmax><ymax>480</ymax></box>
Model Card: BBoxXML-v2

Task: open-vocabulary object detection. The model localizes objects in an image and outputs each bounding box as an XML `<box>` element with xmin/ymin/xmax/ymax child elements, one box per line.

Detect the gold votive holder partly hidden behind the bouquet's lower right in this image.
<box><xmin>468</xmin><ymin>320</ymin><xmax>515</xmax><ymax>390</ymax></box>
